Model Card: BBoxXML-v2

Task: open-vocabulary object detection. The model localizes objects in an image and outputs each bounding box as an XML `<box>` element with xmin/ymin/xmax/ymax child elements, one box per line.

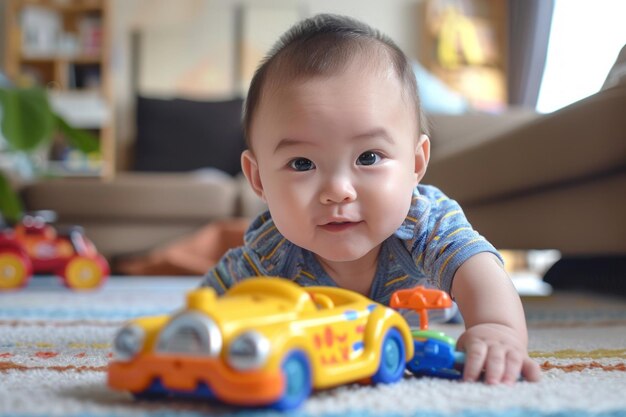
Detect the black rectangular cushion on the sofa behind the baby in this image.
<box><xmin>133</xmin><ymin>97</ymin><xmax>245</xmax><ymax>175</ymax></box>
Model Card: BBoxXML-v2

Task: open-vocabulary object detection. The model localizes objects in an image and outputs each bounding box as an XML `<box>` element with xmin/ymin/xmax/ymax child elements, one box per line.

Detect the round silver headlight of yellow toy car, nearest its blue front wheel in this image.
<box><xmin>228</xmin><ymin>331</ymin><xmax>270</xmax><ymax>371</ymax></box>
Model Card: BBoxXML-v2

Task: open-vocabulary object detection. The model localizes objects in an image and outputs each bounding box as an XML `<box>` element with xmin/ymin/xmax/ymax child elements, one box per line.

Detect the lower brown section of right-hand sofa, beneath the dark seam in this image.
<box><xmin>463</xmin><ymin>172</ymin><xmax>626</xmax><ymax>252</ymax></box>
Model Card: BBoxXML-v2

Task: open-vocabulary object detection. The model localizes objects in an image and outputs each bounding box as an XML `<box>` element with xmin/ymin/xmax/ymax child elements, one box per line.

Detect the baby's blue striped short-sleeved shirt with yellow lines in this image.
<box><xmin>203</xmin><ymin>185</ymin><xmax>502</xmax><ymax>304</ymax></box>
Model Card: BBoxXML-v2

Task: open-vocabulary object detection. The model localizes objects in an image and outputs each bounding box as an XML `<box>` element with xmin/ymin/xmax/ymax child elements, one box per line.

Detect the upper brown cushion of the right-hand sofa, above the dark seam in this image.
<box><xmin>424</xmin><ymin>87</ymin><xmax>626</xmax><ymax>204</ymax></box>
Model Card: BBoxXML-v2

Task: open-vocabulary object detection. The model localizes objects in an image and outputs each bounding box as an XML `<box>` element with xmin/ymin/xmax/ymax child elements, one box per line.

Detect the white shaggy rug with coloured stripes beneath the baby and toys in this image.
<box><xmin>0</xmin><ymin>277</ymin><xmax>626</xmax><ymax>417</ymax></box>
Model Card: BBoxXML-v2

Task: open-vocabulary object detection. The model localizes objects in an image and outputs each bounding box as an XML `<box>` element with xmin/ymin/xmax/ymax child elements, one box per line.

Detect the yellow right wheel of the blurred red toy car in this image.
<box><xmin>61</xmin><ymin>256</ymin><xmax>109</xmax><ymax>290</ymax></box>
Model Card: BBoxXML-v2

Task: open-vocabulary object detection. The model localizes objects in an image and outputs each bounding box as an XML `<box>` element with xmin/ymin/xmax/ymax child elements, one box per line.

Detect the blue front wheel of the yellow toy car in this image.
<box><xmin>272</xmin><ymin>350</ymin><xmax>312</xmax><ymax>410</ymax></box>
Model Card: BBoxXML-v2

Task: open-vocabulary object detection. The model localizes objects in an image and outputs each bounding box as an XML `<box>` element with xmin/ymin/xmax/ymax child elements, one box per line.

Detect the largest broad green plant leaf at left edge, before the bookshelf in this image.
<box><xmin>0</xmin><ymin>88</ymin><xmax>55</xmax><ymax>151</ymax></box>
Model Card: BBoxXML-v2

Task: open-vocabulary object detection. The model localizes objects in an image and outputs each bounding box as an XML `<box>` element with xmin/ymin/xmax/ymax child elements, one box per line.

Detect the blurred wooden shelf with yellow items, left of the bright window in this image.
<box><xmin>419</xmin><ymin>0</ymin><xmax>508</xmax><ymax>111</ymax></box>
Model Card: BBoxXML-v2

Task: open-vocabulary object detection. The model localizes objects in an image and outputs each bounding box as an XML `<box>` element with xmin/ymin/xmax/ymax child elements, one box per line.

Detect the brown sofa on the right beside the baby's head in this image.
<box><xmin>424</xmin><ymin>85</ymin><xmax>626</xmax><ymax>255</ymax></box>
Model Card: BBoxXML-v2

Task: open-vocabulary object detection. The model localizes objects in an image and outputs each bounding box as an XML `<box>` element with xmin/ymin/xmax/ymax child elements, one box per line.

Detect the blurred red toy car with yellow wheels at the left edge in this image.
<box><xmin>0</xmin><ymin>211</ymin><xmax>109</xmax><ymax>291</ymax></box>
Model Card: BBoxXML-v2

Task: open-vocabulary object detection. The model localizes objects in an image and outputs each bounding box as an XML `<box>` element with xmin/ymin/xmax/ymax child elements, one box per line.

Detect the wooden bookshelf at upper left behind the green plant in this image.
<box><xmin>5</xmin><ymin>0</ymin><xmax>115</xmax><ymax>177</ymax></box>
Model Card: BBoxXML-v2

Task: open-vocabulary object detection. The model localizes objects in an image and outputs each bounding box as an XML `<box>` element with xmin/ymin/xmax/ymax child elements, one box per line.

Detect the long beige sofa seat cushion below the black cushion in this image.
<box><xmin>22</xmin><ymin>172</ymin><xmax>238</xmax><ymax>222</ymax></box>
